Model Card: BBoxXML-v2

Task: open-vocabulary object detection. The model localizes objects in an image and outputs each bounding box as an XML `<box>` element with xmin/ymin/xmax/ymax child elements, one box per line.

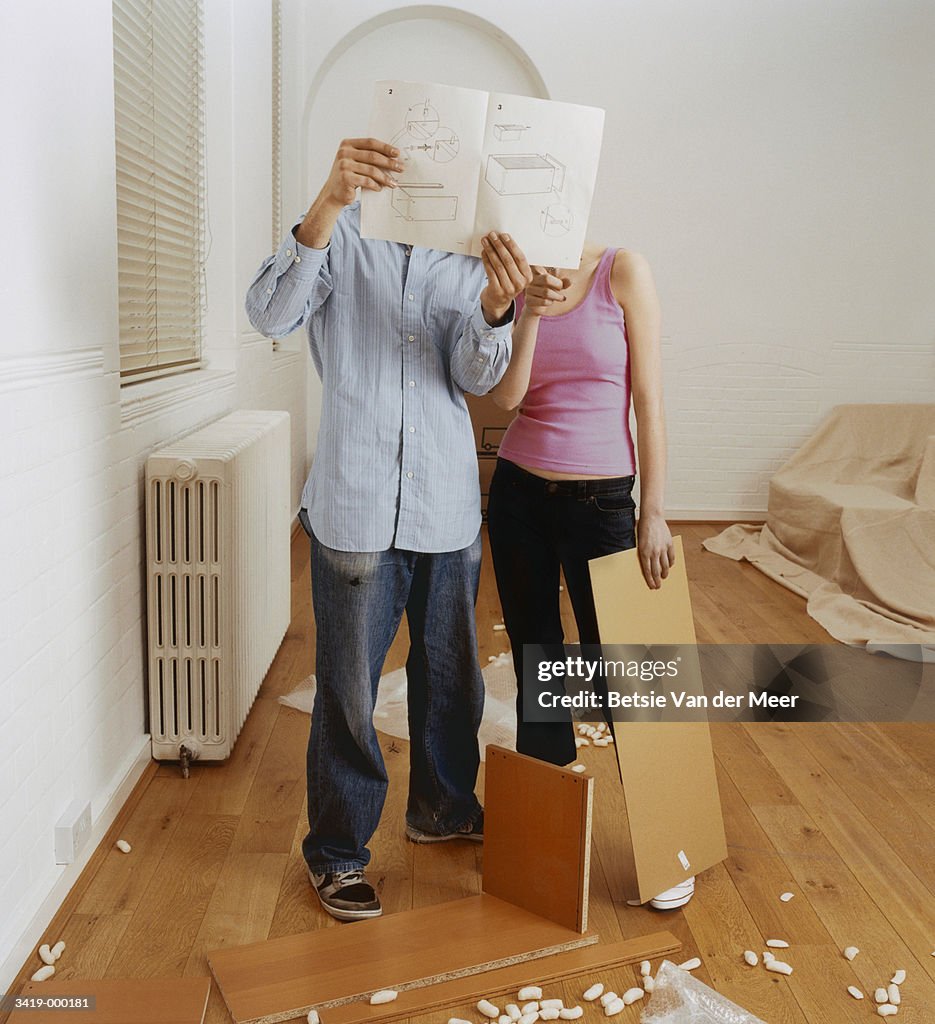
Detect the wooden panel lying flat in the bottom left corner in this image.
<box><xmin>9</xmin><ymin>978</ymin><xmax>211</xmax><ymax>1024</ymax></box>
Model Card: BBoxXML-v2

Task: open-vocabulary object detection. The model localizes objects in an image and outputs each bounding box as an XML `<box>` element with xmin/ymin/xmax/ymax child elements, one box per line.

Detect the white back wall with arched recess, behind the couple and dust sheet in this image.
<box><xmin>284</xmin><ymin>0</ymin><xmax>935</xmax><ymax>515</ymax></box>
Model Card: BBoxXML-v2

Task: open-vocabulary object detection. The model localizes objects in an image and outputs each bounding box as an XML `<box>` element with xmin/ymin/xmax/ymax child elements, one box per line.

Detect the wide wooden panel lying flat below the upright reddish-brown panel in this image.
<box><xmin>208</xmin><ymin>894</ymin><xmax>597</xmax><ymax>1024</ymax></box>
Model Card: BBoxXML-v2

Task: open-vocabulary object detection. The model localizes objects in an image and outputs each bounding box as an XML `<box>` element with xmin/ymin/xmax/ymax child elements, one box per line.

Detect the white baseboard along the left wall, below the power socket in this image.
<box><xmin>0</xmin><ymin>735</ymin><xmax>153</xmax><ymax>992</ymax></box>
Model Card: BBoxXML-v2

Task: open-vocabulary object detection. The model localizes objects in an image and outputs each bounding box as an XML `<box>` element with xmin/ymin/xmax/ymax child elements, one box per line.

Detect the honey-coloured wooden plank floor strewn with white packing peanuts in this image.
<box><xmin>11</xmin><ymin>524</ymin><xmax>935</xmax><ymax>1024</ymax></box>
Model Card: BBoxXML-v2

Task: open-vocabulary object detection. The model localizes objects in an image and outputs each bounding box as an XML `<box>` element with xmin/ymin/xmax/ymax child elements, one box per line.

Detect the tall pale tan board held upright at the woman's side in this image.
<box><xmin>590</xmin><ymin>537</ymin><xmax>727</xmax><ymax>902</ymax></box>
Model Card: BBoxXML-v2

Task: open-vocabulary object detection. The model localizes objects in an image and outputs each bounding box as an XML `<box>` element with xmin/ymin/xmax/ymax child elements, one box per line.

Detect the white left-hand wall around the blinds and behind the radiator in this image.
<box><xmin>0</xmin><ymin>0</ymin><xmax>305</xmax><ymax>978</ymax></box>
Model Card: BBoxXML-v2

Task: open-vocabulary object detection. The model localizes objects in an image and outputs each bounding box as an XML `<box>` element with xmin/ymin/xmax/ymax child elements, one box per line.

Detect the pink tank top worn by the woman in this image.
<box><xmin>500</xmin><ymin>249</ymin><xmax>636</xmax><ymax>476</ymax></box>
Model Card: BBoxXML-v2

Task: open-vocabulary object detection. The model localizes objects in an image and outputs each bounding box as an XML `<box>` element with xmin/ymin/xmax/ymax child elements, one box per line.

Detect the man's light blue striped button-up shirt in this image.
<box><xmin>247</xmin><ymin>203</ymin><xmax>512</xmax><ymax>551</ymax></box>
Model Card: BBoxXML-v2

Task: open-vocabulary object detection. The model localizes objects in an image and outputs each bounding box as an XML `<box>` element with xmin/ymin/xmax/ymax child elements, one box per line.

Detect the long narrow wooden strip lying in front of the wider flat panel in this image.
<box><xmin>322</xmin><ymin>932</ymin><xmax>680</xmax><ymax>1024</ymax></box>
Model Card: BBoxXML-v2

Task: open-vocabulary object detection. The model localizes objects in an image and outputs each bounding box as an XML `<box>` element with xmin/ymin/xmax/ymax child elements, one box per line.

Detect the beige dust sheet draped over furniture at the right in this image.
<box><xmin>705</xmin><ymin>404</ymin><xmax>935</xmax><ymax>646</ymax></box>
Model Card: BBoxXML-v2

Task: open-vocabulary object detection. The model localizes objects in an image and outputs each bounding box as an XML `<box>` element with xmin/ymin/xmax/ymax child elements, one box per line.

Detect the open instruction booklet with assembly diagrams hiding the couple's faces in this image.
<box><xmin>360</xmin><ymin>81</ymin><xmax>604</xmax><ymax>268</ymax></box>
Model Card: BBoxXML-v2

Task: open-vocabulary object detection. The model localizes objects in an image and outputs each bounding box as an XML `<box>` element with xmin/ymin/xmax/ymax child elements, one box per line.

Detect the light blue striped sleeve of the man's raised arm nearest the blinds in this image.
<box><xmin>246</xmin><ymin>226</ymin><xmax>332</xmax><ymax>338</ymax></box>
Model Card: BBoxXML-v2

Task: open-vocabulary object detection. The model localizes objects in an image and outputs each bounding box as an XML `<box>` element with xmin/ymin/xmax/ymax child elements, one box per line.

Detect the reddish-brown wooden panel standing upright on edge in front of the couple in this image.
<box><xmin>483</xmin><ymin>744</ymin><xmax>594</xmax><ymax>932</ymax></box>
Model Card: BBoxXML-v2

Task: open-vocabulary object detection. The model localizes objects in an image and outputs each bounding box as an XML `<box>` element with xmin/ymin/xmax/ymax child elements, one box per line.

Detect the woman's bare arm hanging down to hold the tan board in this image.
<box><xmin>610</xmin><ymin>252</ymin><xmax>675</xmax><ymax>590</ymax></box>
